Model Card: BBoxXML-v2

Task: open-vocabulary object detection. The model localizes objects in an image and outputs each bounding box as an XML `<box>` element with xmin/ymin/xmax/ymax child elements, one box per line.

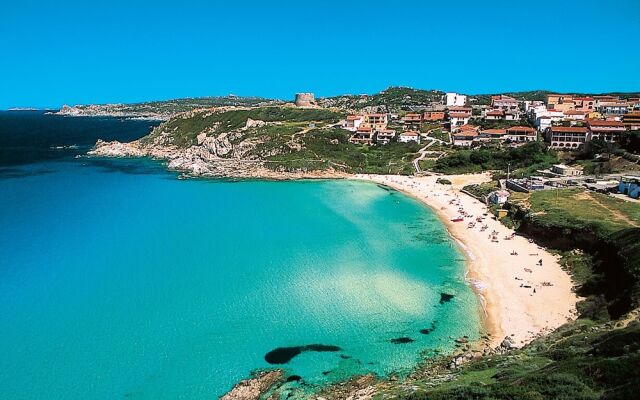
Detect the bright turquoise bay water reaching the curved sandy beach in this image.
<box><xmin>0</xmin><ymin>160</ymin><xmax>480</xmax><ymax>400</ymax></box>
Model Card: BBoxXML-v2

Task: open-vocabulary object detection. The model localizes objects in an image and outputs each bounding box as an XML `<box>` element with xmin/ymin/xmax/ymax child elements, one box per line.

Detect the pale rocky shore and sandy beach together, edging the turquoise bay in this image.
<box><xmin>88</xmin><ymin>141</ymin><xmax>579</xmax><ymax>349</ymax></box>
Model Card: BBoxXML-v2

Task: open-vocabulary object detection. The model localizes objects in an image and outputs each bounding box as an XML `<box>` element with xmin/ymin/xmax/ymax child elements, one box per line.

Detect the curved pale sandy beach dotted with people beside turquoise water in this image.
<box><xmin>355</xmin><ymin>174</ymin><xmax>578</xmax><ymax>347</ymax></box>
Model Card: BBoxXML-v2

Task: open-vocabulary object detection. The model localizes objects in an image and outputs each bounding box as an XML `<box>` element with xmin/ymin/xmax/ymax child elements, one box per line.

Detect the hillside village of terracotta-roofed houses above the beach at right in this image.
<box><xmin>322</xmin><ymin>92</ymin><xmax>640</xmax><ymax>203</ymax></box>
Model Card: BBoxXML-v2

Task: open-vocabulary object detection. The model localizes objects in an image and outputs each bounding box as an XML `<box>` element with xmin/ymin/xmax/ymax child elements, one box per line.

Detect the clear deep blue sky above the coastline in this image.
<box><xmin>0</xmin><ymin>0</ymin><xmax>640</xmax><ymax>108</ymax></box>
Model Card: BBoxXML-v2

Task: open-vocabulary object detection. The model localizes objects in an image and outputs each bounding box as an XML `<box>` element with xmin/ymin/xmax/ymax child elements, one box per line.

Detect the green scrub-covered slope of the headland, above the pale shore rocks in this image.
<box><xmin>141</xmin><ymin>107</ymin><xmax>419</xmax><ymax>174</ymax></box>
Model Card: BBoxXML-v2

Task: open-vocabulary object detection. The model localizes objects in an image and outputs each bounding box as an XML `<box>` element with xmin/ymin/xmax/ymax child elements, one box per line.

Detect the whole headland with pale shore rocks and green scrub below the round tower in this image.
<box><xmin>89</xmin><ymin>107</ymin><xmax>418</xmax><ymax>179</ymax></box>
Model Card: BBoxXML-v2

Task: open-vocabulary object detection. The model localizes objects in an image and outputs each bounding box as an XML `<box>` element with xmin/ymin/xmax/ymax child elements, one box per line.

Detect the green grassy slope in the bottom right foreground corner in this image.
<box><xmin>398</xmin><ymin>319</ymin><xmax>640</xmax><ymax>400</ymax></box>
